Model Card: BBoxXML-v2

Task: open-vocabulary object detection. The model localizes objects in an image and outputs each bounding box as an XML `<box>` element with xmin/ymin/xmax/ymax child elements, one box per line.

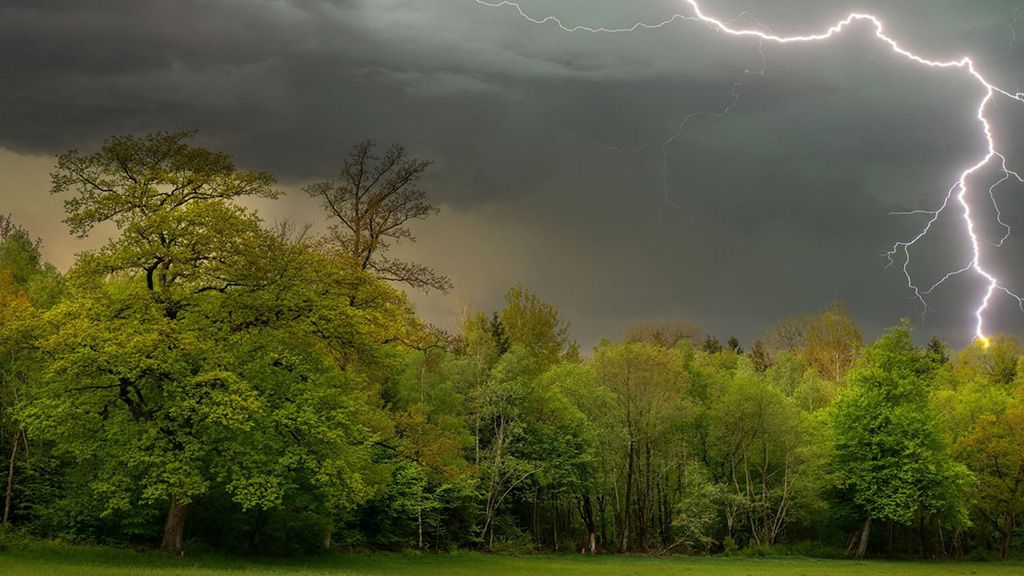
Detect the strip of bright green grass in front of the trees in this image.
<box><xmin>0</xmin><ymin>547</ymin><xmax>1024</xmax><ymax>576</ymax></box>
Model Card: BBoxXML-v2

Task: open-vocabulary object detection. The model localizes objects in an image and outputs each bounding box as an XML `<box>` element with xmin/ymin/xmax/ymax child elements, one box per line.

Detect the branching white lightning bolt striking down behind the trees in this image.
<box><xmin>475</xmin><ymin>0</ymin><xmax>1024</xmax><ymax>345</ymax></box>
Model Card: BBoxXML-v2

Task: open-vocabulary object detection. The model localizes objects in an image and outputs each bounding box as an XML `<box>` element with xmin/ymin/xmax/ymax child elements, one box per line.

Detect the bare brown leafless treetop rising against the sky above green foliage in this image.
<box><xmin>303</xmin><ymin>140</ymin><xmax>452</xmax><ymax>292</ymax></box>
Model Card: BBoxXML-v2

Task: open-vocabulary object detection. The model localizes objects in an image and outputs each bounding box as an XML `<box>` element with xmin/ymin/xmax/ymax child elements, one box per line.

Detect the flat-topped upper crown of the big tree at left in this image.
<box><xmin>52</xmin><ymin>128</ymin><xmax>279</xmax><ymax>293</ymax></box>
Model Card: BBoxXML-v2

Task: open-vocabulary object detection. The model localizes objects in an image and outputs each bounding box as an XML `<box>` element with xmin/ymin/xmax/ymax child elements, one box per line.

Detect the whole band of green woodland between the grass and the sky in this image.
<box><xmin>0</xmin><ymin>133</ymin><xmax>1024</xmax><ymax>558</ymax></box>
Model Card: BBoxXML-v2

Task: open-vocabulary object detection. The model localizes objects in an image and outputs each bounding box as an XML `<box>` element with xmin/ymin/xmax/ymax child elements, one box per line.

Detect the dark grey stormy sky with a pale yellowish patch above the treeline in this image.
<box><xmin>0</xmin><ymin>0</ymin><xmax>1024</xmax><ymax>347</ymax></box>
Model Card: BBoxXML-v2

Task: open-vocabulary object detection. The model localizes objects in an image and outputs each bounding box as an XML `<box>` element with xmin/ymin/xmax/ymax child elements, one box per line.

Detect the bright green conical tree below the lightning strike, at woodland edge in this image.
<box><xmin>831</xmin><ymin>326</ymin><xmax>970</xmax><ymax>557</ymax></box>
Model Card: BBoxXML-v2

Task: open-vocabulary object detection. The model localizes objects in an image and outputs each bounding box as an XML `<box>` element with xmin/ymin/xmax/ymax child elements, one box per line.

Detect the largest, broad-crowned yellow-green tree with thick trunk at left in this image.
<box><xmin>24</xmin><ymin>133</ymin><xmax>410</xmax><ymax>548</ymax></box>
